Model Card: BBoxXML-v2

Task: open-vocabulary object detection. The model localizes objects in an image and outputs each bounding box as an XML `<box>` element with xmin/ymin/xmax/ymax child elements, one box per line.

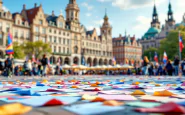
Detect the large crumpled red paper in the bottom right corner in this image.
<box><xmin>135</xmin><ymin>102</ymin><xmax>185</xmax><ymax>113</ymax></box>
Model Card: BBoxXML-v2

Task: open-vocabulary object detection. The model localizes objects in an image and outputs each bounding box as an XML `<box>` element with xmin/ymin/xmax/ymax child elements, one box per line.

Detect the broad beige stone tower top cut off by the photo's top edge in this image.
<box><xmin>66</xmin><ymin>0</ymin><xmax>80</xmax><ymax>22</ymax></box>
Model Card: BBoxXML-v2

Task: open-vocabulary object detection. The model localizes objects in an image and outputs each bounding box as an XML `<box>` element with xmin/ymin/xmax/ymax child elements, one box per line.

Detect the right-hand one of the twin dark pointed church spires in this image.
<box><xmin>166</xmin><ymin>2</ymin><xmax>175</xmax><ymax>26</ymax></box>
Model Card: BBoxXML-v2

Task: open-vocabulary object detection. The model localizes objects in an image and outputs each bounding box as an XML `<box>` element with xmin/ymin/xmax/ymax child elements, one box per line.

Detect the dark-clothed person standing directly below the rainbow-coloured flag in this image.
<box><xmin>6</xmin><ymin>54</ymin><xmax>14</xmax><ymax>77</ymax></box>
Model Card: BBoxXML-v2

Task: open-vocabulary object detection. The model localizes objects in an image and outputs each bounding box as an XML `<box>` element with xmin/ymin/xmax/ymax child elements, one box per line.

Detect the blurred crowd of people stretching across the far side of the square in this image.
<box><xmin>0</xmin><ymin>55</ymin><xmax>185</xmax><ymax>77</ymax></box>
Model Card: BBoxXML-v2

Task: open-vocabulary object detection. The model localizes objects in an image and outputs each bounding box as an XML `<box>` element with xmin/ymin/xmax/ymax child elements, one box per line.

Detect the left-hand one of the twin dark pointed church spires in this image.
<box><xmin>151</xmin><ymin>4</ymin><xmax>160</xmax><ymax>29</ymax></box>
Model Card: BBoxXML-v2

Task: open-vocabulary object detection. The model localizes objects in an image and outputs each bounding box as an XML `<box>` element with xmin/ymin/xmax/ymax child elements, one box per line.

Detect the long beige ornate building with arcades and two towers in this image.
<box><xmin>0</xmin><ymin>0</ymin><xmax>113</xmax><ymax>66</ymax></box>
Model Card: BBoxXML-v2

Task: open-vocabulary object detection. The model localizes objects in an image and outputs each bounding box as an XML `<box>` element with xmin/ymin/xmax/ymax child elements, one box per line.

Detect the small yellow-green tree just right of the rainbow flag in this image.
<box><xmin>13</xmin><ymin>42</ymin><xmax>25</xmax><ymax>59</ymax></box>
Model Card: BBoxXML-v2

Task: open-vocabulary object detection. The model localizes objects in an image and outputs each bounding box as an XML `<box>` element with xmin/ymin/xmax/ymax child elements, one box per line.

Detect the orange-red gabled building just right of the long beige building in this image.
<box><xmin>113</xmin><ymin>34</ymin><xmax>142</xmax><ymax>65</ymax></box>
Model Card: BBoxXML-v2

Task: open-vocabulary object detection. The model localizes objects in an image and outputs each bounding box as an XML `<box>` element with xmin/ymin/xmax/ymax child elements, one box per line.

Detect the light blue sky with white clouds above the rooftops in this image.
<box><xmin>3</xmin><ymin>0</ymin><xmax>185</xmax><ymax>38</ymax></box>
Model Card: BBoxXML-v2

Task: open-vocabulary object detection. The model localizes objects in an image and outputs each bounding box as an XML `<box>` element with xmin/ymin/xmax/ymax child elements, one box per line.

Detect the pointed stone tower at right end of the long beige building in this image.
<box><xmin>100</xmin><ymin>11</ymin><xmax>112</xmax><ymax>36</ymax></box>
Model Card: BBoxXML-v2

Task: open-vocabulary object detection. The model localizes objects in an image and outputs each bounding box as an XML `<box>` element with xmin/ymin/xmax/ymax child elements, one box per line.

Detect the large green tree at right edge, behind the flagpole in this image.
<box><xmin>159</xmin><ymin>26</ymin><xmax>185</xmax><ymax>60</ymax></box>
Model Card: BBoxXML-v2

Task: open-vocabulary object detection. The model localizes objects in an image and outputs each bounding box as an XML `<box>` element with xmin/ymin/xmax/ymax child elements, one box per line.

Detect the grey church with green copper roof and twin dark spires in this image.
<box><xmin>139</xmin><ymin>3</ymin><xmax>176</xmax><ymax>51</ymax></box>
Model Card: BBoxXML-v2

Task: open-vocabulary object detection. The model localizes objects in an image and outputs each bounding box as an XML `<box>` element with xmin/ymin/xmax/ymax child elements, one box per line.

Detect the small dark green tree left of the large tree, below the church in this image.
<box><xmin>143</xmin><ymin>47</ymin><xmax>160</xmax><ymax>61</ymax></box>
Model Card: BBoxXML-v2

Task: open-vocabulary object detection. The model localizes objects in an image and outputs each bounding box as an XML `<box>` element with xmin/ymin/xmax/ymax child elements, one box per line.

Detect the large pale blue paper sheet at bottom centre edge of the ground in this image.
<box><xmin>62</xmin><ymin>102</ymin><xmax>124</xmax><ymax>115</ymax></box>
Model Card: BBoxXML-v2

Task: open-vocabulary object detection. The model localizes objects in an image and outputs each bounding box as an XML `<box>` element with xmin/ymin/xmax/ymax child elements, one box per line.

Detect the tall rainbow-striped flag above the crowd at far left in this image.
<box><xmin>6</xmin><ymin>32</ymin><xmax>14</xmax><ymax>55</ymax></box>
